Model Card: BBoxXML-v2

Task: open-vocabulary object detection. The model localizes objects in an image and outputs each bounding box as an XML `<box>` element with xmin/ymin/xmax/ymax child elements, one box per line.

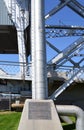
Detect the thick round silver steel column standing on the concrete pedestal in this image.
<box><xmin>31</xmin><ymin>0</ymin><xmax>47</xmax><ymax>99</ymax></box>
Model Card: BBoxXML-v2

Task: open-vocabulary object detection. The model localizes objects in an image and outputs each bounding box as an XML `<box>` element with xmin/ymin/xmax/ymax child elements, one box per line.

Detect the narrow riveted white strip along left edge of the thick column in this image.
<box><xmin>31</xmin><ymin>0</ymin><xmax>36</xmax><ymax>99</ymax></box>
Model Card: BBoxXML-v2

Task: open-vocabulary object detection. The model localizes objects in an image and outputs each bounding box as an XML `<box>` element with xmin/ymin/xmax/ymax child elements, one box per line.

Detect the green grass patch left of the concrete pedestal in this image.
<box><xmin>0</xmin><ymin>112</ymin><xmax>21</xmax><ymax>130</ymax></box>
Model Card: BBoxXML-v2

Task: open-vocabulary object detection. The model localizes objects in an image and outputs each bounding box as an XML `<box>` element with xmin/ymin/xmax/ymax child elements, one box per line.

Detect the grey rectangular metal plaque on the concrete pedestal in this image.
<box><xmin>28</xmin><ymin>102</ymin><xmax>51</xmax><ymax>120</ymax></box>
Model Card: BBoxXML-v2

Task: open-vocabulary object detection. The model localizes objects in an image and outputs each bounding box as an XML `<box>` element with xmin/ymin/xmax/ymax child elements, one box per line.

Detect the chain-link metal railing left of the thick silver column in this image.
<box><xmin>0</xmin><ymin>61</ymin><xmax>31</xmax><ymax>76</ymax></box>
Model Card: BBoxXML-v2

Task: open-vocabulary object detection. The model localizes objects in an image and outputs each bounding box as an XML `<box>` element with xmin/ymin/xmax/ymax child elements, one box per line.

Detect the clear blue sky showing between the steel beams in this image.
<box><xmin>0</xmin><ymin>0</ymin><xmax>84</xmax><ymax>69</ymax></box>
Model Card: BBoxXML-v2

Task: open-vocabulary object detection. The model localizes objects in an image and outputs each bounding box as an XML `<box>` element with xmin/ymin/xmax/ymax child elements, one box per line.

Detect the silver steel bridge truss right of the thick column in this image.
<box><xmin>45</xmin><ymin>0</ymin><xmax>84</xmax><ymax>99</ymax></box>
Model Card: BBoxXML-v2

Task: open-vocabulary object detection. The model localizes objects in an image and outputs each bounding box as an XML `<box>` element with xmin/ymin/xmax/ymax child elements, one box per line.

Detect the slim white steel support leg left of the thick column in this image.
<box><xmin>17</xmin><ymin>10</ymin><xmax>27</xmax><ymax>78</ymax></box>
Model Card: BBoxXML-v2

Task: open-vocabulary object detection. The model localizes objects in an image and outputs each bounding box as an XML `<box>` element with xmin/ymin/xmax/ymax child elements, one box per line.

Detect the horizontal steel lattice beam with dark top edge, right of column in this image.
<box><xmin>45</xmin><ymin>25</ymin><xmax>84</xmax><ymax>38</ymax></box>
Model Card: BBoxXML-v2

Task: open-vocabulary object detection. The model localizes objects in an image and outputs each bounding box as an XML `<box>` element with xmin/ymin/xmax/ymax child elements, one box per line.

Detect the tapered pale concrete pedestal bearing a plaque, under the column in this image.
<box><xmin>18</xmin><ymin>99</ymin><xmax>63</xmax><ymax>130</ymax></box>
